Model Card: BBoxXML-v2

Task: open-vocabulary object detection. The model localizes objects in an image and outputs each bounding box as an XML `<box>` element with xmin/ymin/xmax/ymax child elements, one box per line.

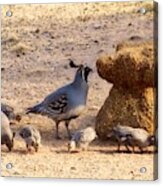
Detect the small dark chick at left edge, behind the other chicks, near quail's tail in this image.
<box><xmin>1</xmin><ymin>103</ymin><xmax>21</xmax><ymax>121</ymax></box>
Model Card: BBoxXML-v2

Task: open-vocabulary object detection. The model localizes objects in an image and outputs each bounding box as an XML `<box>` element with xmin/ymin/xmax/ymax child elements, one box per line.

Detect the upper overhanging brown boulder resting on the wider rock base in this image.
<box><xmin>96</xmin><ymin>41</ymin><xmax>155</xmax><ymax>89</ymax></box>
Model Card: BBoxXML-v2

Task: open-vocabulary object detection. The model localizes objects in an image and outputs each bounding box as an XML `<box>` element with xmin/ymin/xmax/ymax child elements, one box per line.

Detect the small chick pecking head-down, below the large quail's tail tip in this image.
<box><xmin>19</xmin><ymin>125</ymin><xmax>41</xmax><ymax>152</ymax></box>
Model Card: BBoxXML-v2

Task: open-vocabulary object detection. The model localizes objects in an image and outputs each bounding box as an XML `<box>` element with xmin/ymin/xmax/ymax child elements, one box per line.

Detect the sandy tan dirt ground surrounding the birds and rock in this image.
<box><xmin>1</xmin><ymin>3</ymin><xmax>157</xmax><ymax>180</ymax></box>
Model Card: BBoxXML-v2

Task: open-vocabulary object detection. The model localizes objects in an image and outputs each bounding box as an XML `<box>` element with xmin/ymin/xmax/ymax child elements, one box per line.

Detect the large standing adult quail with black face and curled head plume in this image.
<box><xmin>27</xmin><ymin>61</ymin><xmax>92</xmax><ymax>139</ymax></box>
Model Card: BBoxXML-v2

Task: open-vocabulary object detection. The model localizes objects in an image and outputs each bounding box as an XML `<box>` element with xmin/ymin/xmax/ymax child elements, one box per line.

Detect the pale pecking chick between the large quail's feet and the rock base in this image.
<box><xmin>68</xmin><ymin>127</ymin><xmax>97</xmax><ymax>152</ymax></box>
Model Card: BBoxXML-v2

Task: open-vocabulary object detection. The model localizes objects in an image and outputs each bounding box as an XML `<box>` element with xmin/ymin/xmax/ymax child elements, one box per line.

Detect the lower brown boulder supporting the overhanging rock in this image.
<box><xmin>96</xmin><ymin>88</ymin><xmax>155</xmax><ymax>139</ymax></box>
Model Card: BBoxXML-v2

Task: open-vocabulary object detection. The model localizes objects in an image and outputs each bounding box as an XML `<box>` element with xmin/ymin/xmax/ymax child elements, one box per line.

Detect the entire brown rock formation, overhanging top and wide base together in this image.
<box><xmin>96</xmin><ymin>41</ymin><xmax>156</xmax><ymax>139</ymax></box>
